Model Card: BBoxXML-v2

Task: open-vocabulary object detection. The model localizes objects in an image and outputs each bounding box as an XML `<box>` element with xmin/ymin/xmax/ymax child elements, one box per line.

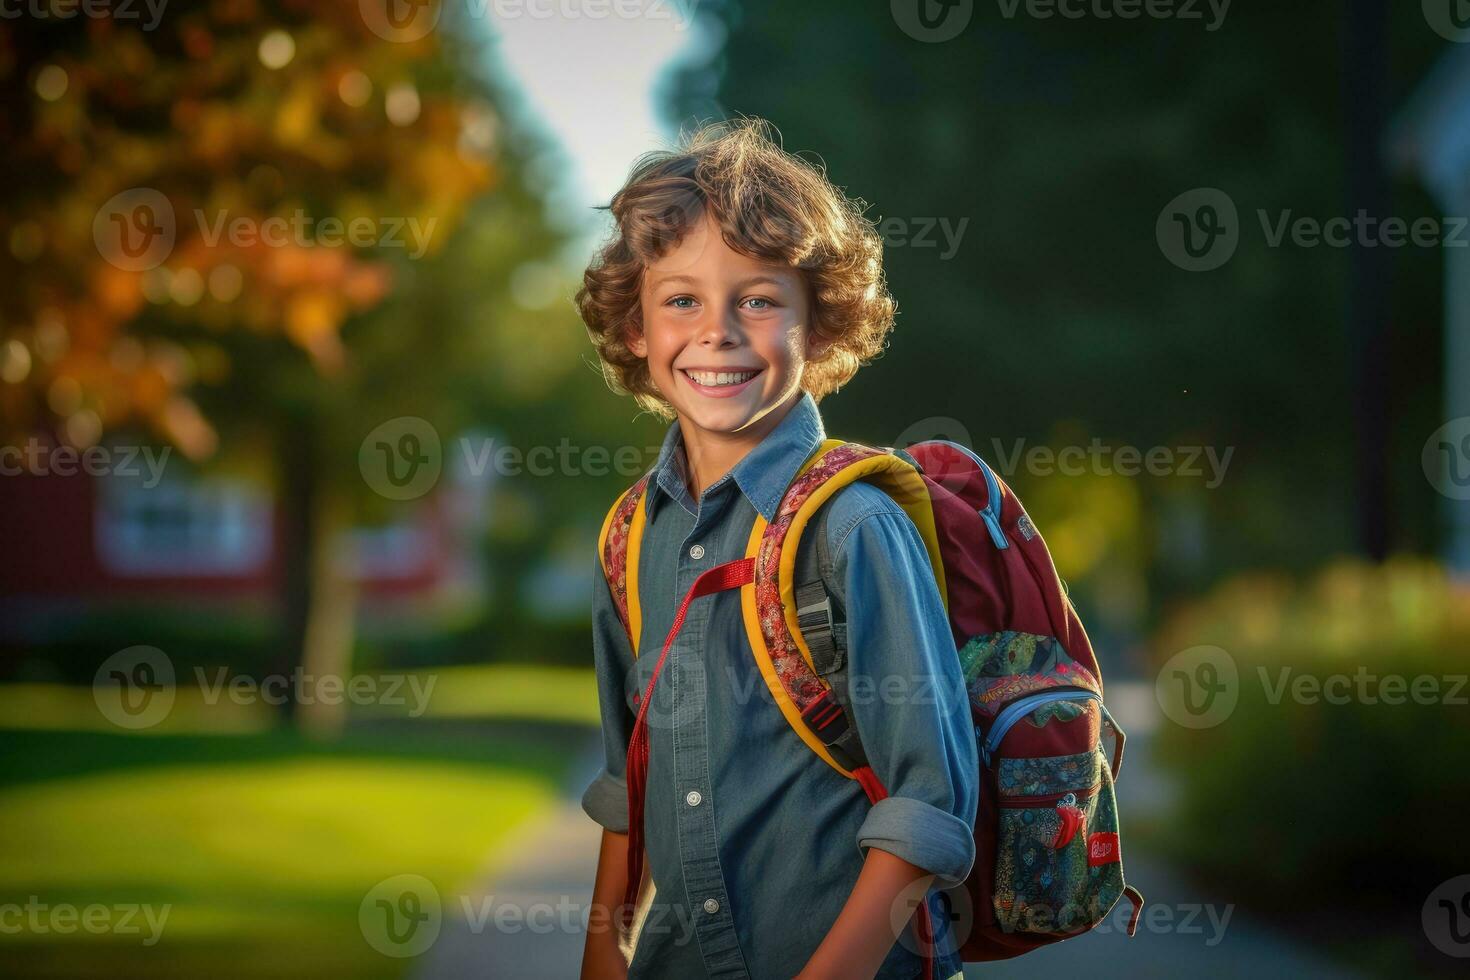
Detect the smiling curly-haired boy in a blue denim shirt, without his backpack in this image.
<box><xmin>578</xmin><ymin>120</ymin><xmax>978</xmax><ymax>980</ymax></box>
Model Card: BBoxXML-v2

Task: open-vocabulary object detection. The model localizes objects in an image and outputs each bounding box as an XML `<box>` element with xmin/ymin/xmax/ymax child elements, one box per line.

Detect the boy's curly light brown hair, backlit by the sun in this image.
<box><xmin>576</xmin><ymin>118</ymin><xmax>895</xmax><ymax>420</ymax></box>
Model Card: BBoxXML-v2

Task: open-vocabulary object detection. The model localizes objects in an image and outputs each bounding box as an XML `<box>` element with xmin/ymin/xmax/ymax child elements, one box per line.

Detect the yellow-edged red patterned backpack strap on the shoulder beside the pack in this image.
<box><xmin>741</xmin><ymin>439</ymin><xmax>950</xmax><ymax>779</ymax></box>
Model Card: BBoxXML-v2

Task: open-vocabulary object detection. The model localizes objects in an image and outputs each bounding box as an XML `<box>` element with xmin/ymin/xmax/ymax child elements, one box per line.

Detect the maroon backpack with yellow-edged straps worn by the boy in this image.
<box><xmin>598</xmin><ymin>439</ymin><xmax>1144</xmax><ymax>979</ymax></box>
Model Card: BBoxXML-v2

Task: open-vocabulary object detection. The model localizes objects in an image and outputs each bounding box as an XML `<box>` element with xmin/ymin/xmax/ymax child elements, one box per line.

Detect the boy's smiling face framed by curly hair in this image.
<box><xmin>628</xmin><ymin>212</ymin><xmax>820</xmax><ymax>435</ymax></box>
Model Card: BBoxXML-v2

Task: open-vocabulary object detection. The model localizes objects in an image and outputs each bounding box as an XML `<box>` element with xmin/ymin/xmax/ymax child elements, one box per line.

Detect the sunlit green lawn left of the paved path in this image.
<box><xmin>0</xmin><ymin>671</ymin><xmax>595</xmax><ymax>980</ymax></box>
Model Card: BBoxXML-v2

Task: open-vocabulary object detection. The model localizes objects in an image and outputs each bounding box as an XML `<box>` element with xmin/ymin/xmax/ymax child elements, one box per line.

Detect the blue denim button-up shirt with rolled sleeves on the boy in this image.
<box><xmin>582</xmin><ymin>392</ymin><xmax>979</xmax><ymax>980</ymax></box>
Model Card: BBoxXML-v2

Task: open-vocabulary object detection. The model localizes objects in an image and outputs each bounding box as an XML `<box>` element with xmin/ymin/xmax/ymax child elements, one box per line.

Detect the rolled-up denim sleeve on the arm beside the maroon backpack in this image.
<box><xmin>832</xmin><ymin>501</ymin><xmax>979</xmax><ymax>886</ymax></box>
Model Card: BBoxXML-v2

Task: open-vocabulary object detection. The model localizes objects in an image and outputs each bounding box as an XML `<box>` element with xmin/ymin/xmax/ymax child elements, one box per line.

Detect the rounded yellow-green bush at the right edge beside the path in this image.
<box><xmin>1154</xmin><ymin>558</ymin><xmax>1470</xmax><ymax>918</ymax></box>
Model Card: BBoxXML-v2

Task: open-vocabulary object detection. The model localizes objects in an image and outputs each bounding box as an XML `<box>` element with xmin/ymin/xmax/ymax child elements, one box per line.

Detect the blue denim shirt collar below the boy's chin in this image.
<box><xmin>647</xmin><ymin>389</ymin><xmax>826</xmax><ymax>522</ymax></box>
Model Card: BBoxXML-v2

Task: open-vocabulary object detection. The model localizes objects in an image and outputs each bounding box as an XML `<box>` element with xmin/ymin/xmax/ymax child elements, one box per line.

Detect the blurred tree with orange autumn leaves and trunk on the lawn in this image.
<box><xmin>0</xmin><ymin>0</ymin><xmax>557</xmax><ymax>729</ymax></box>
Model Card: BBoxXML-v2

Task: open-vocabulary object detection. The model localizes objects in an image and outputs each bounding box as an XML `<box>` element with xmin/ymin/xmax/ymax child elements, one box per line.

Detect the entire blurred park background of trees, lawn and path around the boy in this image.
<box><xmin>0</xmin><ymin>0</ymin><xmax>1470</xmax><ymax>977</ymax></box>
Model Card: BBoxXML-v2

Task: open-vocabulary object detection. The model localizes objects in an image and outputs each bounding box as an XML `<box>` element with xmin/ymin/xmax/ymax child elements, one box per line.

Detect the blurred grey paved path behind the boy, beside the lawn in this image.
<box><xmin>412</xmin><ymin>682</ymin><xmax>1355</xmax><ymax>980</ymax></box>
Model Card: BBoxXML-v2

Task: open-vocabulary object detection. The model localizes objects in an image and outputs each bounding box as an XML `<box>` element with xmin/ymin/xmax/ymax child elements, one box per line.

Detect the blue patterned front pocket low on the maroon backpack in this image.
<box><xmin>992</xmin><ymin>745</ymin><xmax>1123</xmax><ymax>934</ymax></box>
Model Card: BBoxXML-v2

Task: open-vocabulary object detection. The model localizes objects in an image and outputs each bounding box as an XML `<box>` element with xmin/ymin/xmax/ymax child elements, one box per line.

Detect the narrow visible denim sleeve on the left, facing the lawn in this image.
<box><xmin>582</xmin><ymin>557</ymin><xmax>634</xmax><ymax>833</ymax></box>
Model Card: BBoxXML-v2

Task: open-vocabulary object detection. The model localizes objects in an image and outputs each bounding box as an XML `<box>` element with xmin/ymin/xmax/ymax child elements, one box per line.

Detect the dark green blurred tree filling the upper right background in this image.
<box><xmin>669</xmin><ymin>0</ymin><xmax>1444</xmax><ymax>637</ymax></box>
